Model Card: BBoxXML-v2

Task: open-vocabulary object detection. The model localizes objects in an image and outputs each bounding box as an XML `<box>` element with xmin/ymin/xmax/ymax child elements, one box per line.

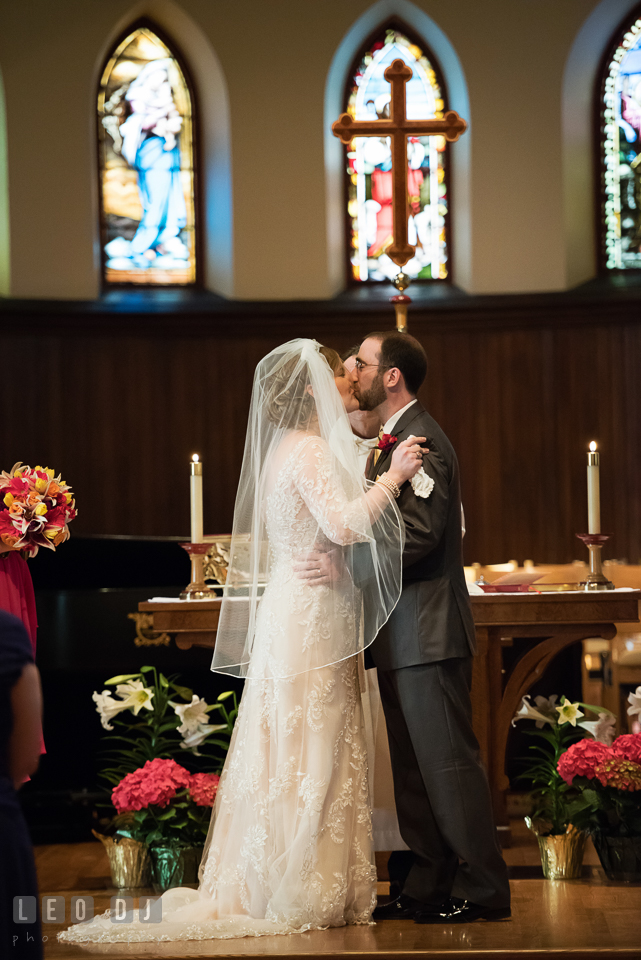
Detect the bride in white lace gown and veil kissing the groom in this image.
<box><xmin>59</xmin><ymin>339</ymin><xmax>424</xmax><ymax>943</ymax></box>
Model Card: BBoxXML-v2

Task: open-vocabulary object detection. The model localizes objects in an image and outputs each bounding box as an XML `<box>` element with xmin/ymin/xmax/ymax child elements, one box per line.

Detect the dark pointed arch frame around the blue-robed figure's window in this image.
<box><xmin>93</xmin><ymin>17</ymin><xmax>205</xmax><ymax>292</ymax></box>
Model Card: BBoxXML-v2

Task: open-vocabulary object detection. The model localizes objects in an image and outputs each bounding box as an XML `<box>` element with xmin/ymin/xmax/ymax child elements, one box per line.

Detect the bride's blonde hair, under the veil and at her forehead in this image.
<box><xmin>265</xmin><ymin>346</ymin><xmax>344</xmax><ymax>430</ymax></box>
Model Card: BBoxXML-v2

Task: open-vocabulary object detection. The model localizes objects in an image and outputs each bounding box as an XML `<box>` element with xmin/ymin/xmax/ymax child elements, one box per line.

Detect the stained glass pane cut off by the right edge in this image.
<box><xmin>600</xmin><ymin>13</ymin><xmax>641</xmax><ymax>270</ymax></box>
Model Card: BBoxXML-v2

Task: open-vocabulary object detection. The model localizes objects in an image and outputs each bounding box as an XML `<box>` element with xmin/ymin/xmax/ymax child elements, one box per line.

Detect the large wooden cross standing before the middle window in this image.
<box><xmin>332</xmin><ymin>60</ymin><xmax>467</xmax><ymax>268</ymax></box>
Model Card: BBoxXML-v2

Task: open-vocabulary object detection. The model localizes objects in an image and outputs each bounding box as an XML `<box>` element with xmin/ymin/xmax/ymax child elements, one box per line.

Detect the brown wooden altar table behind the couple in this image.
<box><xmin>138</xmin><ymin>590</ymin><xmax>641</xmax><ymax>828</ymax></box>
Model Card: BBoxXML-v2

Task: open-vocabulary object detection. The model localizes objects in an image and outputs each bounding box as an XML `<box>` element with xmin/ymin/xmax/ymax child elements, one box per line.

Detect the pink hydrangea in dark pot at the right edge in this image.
<box><xmin>558</xmin><ymin>733</ymin><xmax>641</xmax><ymax>881</ymax></box>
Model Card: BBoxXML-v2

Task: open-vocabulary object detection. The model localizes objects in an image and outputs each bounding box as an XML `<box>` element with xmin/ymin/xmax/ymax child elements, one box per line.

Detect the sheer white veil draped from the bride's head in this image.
<box><xmin>212</xmin><ymin>339</ymin><xmax>404</xmax><ymax>679</ymax></box>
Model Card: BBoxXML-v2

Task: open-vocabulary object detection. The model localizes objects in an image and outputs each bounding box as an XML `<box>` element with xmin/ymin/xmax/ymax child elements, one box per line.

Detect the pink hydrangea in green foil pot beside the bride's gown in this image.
<box><xmin>111</xmin><ymin>758</ymin><xmax>220</xmax><ymax>892</ymax></box>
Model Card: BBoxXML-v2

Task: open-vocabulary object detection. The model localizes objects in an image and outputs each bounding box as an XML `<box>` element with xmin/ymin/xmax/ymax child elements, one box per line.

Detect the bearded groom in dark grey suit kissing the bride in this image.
<box><xmin>354</xmin><ymin>331</ymin><xmax>510</xmax><ymax>923</ymax></box>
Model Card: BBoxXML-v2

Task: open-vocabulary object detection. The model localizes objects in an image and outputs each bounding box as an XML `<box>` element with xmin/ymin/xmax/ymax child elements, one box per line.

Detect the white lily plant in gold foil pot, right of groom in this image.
<box><xmin>512</xmin><ymin>694</ymin><xmax>616</xmax><ymax>880</ymax></box>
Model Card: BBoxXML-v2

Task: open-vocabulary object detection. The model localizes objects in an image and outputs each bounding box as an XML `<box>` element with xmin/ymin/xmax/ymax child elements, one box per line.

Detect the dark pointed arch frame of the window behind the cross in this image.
<box><xmin>341</xmin><ymin>16</ymin><xmax>454</xmax><ymax>289</ymax></box>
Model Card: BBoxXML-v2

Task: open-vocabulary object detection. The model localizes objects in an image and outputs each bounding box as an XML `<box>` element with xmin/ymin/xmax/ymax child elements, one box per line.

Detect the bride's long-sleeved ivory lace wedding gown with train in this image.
<box><xmin>61</xmin><ymin>434</ymin><xmax>386</xmax><ymax>942</ymax></box>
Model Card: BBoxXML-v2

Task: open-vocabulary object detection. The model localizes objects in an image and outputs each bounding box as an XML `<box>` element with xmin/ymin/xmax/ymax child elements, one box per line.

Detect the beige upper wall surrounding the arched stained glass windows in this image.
<box><xmin>0</xmin><ymin>0</ymin><xmax>632</xmax><ymax>299</ymax></box>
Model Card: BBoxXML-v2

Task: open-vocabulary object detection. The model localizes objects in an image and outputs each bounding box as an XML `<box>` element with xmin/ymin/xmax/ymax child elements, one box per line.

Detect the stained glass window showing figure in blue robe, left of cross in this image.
<box><xmin>98</xmin><ymin>26</ymin><xmax>196</xmax><ymax>285</ymax></box>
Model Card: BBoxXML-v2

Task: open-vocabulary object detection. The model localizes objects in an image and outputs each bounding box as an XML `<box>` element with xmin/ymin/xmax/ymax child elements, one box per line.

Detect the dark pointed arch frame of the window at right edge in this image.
<box><xmin>593</xmin><ymin>3</ymin><xmax>641</xmax><ymax>277</ymax></box>
